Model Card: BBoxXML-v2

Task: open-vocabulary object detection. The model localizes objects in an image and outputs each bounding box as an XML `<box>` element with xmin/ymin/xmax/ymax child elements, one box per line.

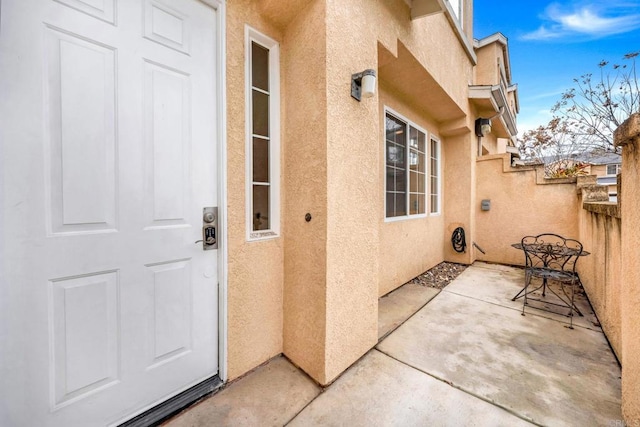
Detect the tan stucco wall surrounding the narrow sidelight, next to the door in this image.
<box><xmin>226</xmin><ymin>0</ymin><xmax>284</xmax><ymax>379</ymax></box>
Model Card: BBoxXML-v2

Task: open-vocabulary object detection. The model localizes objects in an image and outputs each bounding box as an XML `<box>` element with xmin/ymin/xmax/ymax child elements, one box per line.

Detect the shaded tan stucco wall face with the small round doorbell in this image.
<box><xmin>282</xmin><ymin>1</ymin><xmax>328</xmax><ymax>383</ymax></box>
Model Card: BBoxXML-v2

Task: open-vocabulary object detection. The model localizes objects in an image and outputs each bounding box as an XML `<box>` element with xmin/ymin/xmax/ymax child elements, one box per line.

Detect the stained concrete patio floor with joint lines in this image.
<box><xmin>165</xmin><ymin>263</ymin><xmax>622</xmax><ymax>427</ymax></box>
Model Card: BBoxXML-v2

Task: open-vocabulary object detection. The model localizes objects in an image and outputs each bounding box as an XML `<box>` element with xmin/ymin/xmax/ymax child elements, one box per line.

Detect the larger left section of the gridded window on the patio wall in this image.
<box><xmin>385</xmin><ymin>112</ymin><xmax>427</xmax><ymax>218</ymax></box>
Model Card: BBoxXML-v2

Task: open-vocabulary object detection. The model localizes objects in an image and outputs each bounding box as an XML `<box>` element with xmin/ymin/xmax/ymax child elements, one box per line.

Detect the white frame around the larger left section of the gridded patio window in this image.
<box><xmin>382</xmin><ymin>106</ymin><xmax>430</xmax><ymax>222</ymax></box>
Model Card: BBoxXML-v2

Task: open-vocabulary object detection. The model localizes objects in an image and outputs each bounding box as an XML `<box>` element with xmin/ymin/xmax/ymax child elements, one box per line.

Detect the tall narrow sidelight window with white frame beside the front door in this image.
<box><xmin>245</xmin><ymin>27</ymin><xmax>280</xmax><ymax>239</ymax></box>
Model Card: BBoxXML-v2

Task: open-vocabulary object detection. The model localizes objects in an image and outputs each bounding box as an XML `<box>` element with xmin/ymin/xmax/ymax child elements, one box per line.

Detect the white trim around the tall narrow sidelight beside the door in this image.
<box><xmin>244</xmin><ymin>25</ymin><xmax>280</xmax><ymax>241</ymax></box>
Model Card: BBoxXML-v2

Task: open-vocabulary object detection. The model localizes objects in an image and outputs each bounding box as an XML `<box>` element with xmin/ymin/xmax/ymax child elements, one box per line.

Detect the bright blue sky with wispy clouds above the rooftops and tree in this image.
<box><xmin>474</xmin><ymin>0</ymin><xmax>640</xmax><ymax>135</ymax></box>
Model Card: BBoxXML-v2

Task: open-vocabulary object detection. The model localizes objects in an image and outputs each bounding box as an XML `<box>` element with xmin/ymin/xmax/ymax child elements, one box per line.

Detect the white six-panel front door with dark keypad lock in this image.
<box><xmin>0</xmin><ymin>0</ymin><xmax>221</xmax><ymax>426</ymax></box>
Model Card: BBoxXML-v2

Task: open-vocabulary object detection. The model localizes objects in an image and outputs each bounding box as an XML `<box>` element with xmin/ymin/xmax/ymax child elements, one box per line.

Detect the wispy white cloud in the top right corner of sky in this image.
<box><xmin>522</xmin><ymin>1</ymin><xmax>640</xmax><ymax>40</ymax></box>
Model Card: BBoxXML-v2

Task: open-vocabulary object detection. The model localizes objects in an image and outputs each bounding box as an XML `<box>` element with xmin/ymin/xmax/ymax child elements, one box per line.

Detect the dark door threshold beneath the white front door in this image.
<box><xmin>118</xmin><ymin>375</ymin><xmax>224</xmax><ymax>427</ymax></box>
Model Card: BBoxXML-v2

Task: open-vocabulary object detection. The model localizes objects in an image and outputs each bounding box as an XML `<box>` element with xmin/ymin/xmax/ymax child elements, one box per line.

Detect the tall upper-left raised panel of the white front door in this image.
<box><xmin>45</xmin><ymin>27</ymin><xmax>116</xmax><ymax>233</ymax></box>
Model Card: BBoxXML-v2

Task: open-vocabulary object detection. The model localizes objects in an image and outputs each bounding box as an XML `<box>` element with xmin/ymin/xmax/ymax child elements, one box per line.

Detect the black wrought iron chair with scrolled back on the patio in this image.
<box><xmin>521</xmin><ymin>233</ymin><xmax>583</xmax><ymax>329</ymax></box>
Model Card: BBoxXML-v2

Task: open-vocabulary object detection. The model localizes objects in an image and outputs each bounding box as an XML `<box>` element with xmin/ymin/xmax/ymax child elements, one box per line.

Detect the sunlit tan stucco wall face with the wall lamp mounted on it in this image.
<box><xmin>325</xmin><ymin>0</ymin><xmax>383</xmax><ymax>382</ymax></box>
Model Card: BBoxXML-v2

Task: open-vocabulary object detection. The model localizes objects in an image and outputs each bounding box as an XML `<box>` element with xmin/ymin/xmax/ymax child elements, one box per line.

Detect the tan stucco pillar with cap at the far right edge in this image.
<box><xmin>614</xmin><ymin>114</ymin><xmax>640</xmax><ymax>425</ymax></box>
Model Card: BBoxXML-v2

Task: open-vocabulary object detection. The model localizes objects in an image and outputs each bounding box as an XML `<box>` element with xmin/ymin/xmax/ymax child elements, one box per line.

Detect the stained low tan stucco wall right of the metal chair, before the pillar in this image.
<box><xmin>578</xmin><ymin>207</ymin><xmax>622</xmax><ymax>359</ymax></box>
